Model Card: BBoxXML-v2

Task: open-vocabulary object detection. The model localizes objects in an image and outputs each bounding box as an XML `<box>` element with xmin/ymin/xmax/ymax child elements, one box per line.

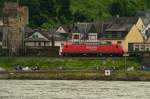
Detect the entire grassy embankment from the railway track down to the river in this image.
<box><xmin>0</xmin><ymin>57</ymin><xmax>150</xmax><ymax>81</ymax></box>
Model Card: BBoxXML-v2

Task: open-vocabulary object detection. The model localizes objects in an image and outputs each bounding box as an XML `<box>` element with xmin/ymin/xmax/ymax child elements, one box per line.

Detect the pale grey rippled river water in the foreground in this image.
<box><xmin>0</xmin><ymin>80</ymin><xmax>150</xmax><ymax>99</ymax></box>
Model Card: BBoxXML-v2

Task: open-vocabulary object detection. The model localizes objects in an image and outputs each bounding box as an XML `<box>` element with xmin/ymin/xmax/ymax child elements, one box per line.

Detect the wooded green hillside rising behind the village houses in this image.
<box><xmin>0</xmin><ymin>0</ymin><xmax>150</xmax><ymax>28</ymax></box>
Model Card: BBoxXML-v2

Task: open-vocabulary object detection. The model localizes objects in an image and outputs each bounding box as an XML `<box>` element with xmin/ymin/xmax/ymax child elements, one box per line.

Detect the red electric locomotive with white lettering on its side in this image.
<box><xmin>61</xmin><ymin>43</ymin><xmax>124</xmax><ymax>56</ymax></box>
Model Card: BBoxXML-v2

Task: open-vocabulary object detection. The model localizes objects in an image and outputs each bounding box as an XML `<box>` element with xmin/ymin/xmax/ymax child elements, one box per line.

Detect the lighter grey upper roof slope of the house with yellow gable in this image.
<box><xmin>105</xmin><ymin>24</ymin><xmax>132</xmax><ymax>32</ymax></box>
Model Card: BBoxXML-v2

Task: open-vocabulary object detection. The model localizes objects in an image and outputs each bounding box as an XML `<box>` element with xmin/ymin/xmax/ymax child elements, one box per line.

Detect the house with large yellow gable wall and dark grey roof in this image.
<box><xmin>103</xmin><ymin>24</ymin><xmax>144</xmax><ymax>52</ymax></box>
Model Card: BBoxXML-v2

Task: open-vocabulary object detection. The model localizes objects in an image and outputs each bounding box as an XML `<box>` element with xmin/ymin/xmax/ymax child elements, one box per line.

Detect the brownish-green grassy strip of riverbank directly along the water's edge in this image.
<box><xmin>0</xmin><ymin>71</ymin><xmax>150</xmax><ymax>81</ymax></box>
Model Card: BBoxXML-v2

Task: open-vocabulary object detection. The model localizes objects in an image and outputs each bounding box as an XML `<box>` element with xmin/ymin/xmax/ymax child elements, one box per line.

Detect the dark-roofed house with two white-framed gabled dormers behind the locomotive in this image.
<box><xmin>71</xmin><ymin>23</ymin><xmax>99</xmax><ymax>43</ymax></box>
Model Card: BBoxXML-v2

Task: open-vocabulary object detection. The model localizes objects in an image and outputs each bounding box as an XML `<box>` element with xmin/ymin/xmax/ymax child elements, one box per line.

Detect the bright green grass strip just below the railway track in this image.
<box><xmin>0</xmin><ymin>57</ymin><xmax>141</xmax><ymax>70</ymax></box>
